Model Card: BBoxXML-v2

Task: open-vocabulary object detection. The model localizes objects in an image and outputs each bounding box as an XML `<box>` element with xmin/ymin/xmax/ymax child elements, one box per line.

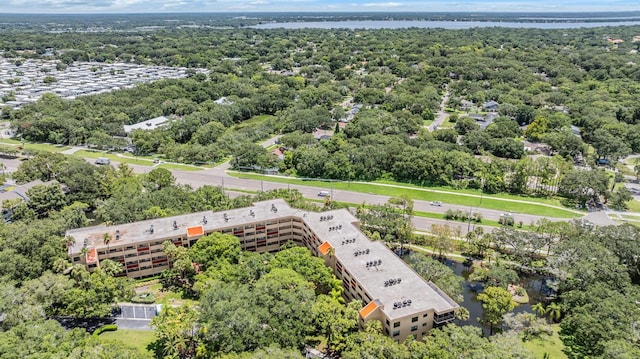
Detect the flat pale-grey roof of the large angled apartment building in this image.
<box><xmin>67</xmin><ymin>199</ymin><xmax>459</xmax><ymax>320</ymax></box>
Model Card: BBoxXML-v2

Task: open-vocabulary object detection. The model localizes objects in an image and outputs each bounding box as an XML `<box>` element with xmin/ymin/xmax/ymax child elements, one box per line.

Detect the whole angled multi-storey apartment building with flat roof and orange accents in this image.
<box><xmin>67</xmin><ymin>200</ymin><xmax>459</xmax><ymax>341</ymax></box>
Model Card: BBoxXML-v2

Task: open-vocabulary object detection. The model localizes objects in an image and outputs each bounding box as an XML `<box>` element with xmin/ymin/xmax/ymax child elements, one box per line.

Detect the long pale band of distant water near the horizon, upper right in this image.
<box><xmin>250</xmin><ymin>20</ymin><xmax>640</xmax><ymax>30</ymax></box>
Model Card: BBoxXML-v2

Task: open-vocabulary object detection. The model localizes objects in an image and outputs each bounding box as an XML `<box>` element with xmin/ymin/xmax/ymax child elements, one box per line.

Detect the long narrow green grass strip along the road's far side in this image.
<box><xmin>228</xmin><ymin>171</ymin><xmax>581</xmax><ymax>218</ymax></box>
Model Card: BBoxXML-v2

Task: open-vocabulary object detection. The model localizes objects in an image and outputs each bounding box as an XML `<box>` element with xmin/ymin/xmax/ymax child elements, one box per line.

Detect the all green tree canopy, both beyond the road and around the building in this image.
<box><xmin>0</xmin><ymin>16</ymin><xmax>640</xmax><ymax>359</ymax></box>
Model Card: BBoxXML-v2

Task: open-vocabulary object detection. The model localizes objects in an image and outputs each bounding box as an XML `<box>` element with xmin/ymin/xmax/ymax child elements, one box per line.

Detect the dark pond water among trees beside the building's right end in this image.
<box><xmin>444</xmin><ymin>260</ymin><xmax>550</xmax><ymax>335</ymax></box>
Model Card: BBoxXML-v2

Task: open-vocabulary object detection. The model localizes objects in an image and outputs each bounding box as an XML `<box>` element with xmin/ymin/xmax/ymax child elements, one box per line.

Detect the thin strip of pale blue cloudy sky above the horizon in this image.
<box><xmin>0</xmin><ymin>0</ymin><xmax>640</xmax><ymax>14</ymax></box>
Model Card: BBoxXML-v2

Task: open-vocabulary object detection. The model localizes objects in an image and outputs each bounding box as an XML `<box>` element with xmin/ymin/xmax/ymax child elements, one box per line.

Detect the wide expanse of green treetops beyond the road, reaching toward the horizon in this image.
<box><xmin>0</xmin><ymin>27</ymin><xmax>640</xmax><ymax>205</ymax></box>
